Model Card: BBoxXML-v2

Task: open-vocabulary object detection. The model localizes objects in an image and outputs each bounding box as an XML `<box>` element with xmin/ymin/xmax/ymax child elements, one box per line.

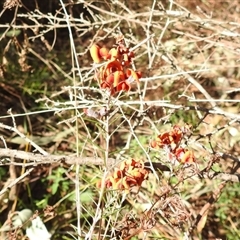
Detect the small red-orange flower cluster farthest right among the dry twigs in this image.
<box><xmin>150</xmin><ymin>125</ymin><xmax>195</xmax><ymax>163</ymax></box>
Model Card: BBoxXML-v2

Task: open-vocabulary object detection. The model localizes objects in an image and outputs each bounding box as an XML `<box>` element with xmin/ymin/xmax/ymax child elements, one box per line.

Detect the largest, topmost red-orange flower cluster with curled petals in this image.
<box><xmin>90</xmin><ymin>39</ymin><xmax>141</xmax><ymax>95</ymax></box>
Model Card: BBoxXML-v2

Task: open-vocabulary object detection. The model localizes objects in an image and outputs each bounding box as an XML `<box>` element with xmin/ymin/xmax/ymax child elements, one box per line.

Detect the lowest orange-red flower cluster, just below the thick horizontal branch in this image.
<box><xmin>99</xmin><ymin>159</ymin><xmax>149</xmax><ymax>192</ymax></box>
